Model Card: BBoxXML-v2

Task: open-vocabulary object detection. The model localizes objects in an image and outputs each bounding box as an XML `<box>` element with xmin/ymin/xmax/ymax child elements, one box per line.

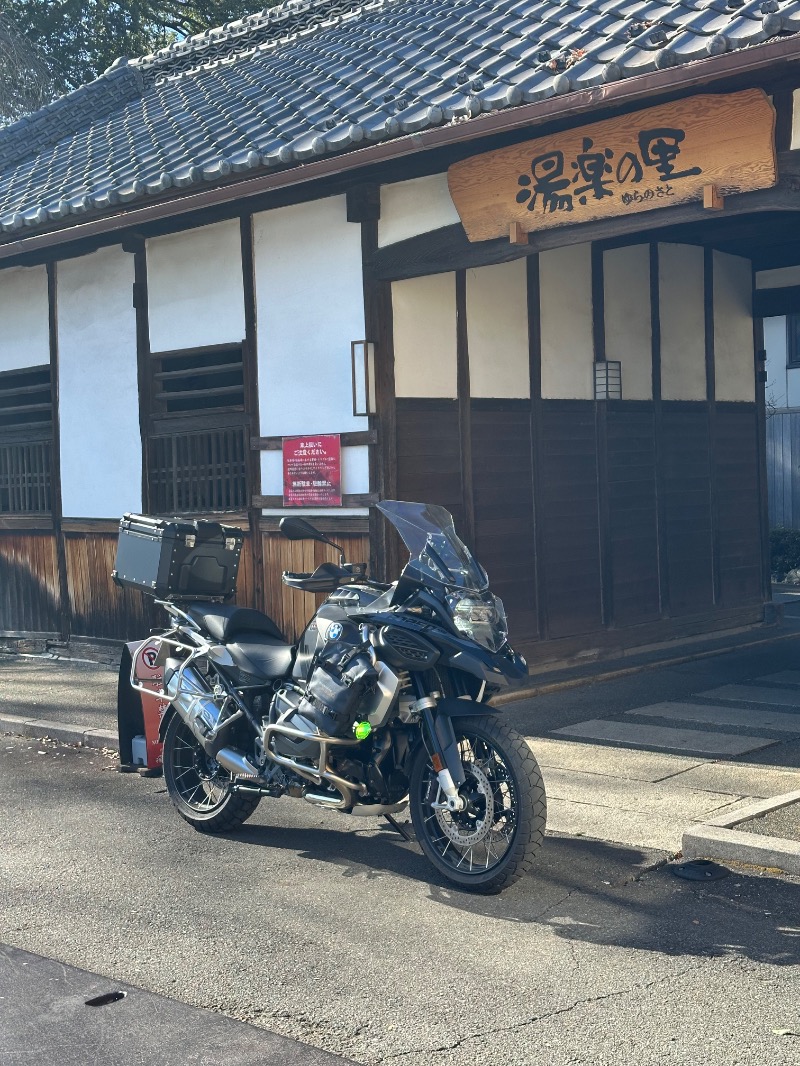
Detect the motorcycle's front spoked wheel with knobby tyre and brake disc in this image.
<box><xmin>410</xmin><ymin>716</ymin><xmax>547</xmax><ymax>894</ymax></box>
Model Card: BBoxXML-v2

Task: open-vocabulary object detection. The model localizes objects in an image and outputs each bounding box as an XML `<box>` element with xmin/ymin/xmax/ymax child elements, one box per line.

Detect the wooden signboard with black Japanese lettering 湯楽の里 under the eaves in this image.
<box><xmin>447</xmin><ymin>88</ymin><xmax>777</xmax><ymax>241</ymax></box>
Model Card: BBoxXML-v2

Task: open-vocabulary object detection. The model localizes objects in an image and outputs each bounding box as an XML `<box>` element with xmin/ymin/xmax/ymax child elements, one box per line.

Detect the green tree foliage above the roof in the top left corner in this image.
<box><xmin>0</xmin><ymin>0</ymin><xmax>274</xmax><ymax>117</ymax></box>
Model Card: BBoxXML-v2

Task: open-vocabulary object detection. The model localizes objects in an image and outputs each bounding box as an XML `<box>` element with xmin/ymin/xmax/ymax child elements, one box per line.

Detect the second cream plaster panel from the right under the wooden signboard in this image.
<box><xmin>658</xmin><ymin>244</ymin><xmax>706</xmax><ymax>400</ymax></box>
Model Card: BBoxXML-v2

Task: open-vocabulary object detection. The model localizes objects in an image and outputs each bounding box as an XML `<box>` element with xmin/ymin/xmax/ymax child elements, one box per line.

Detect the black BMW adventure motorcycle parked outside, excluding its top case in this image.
<box><xmin>131</xmin><ymin>500</ymin><xmax>546</xmax><ymax>893</ymax></box>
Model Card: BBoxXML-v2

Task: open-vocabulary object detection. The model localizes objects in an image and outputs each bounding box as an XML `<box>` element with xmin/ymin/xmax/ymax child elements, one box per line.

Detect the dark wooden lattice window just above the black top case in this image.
<box><xmin>147</xmin><ymin>345</ymin><xmax>250</xmax><ymax>514</ymax></box>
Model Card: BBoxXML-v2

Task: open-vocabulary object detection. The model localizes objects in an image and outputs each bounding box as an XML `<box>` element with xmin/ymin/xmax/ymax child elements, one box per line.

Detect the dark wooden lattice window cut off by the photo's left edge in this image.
<box><xmin>0</xmin><ymin>366</ymin><xmax>52</xmax><ymax>515</ymax></box>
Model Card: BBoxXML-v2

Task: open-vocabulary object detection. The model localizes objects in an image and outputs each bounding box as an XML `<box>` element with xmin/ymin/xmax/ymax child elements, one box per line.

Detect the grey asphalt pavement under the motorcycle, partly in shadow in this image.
<box><xmin>0</xmin><ymin>737</ymin><xmax>800</xmax><ymax>1066</ymax></box>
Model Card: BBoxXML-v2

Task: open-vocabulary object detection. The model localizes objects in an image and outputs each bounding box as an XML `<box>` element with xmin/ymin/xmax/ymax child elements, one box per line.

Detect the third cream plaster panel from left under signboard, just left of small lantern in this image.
<box><xmin>539</xmin><ymin>244</ymin><xmax>594</xmax><ymax>400</ymax></box>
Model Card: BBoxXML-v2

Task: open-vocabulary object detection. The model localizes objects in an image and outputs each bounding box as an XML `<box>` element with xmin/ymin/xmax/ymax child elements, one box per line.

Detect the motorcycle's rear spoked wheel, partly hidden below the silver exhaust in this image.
<box><xmin>164</xmin><ymin>712</ymin><xmax>261</xmax><ymax>833</ymax></box>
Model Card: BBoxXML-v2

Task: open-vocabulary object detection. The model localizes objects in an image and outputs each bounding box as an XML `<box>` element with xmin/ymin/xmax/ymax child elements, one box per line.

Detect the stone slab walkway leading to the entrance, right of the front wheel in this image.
<box><xmin>530</xmin><ymin>671</ymin><xmax>800</xmax><ymax>853</ymax></box>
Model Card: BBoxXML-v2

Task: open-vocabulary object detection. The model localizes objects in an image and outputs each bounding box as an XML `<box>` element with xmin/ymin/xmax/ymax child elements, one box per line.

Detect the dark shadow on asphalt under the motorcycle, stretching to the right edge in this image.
<box><xmin>217</xmin><ymin>823</ymin><xmax>800</xmax><ymax>966</ymax></box>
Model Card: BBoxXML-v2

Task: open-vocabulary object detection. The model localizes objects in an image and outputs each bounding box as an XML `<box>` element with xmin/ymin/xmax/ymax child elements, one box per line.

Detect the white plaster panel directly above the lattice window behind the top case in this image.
<box><xmin>147</xmin><ymin>221</ymin><xmax>244</xmax><ymax>352</ymax></box>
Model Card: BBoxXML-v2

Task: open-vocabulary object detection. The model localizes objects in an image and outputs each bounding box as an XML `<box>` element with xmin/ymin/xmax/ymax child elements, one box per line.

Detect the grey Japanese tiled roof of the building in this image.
<box><xmin>0</xmin><ymin>0</ymin><xmax>800</xmax><ymax>237</ymax></box>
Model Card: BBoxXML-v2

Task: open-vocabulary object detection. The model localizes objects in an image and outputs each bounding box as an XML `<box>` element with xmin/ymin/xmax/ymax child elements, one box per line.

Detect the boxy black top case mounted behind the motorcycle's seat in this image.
<box><xmin>111</xmin><ymin>515</ymin><xmax>244</xmax><ymax>600</ymax></box>
